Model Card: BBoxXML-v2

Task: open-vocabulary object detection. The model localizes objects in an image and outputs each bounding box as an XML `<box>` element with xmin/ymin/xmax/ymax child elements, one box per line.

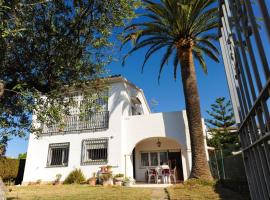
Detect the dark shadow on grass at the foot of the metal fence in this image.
<box><xmin>214</xmin><ymin>180</ymin><xmax>250</xmax><ymax>200</ymax></box>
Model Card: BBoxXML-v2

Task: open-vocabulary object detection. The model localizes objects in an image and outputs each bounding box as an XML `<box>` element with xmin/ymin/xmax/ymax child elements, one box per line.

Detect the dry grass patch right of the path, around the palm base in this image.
<box><xmin>167</xmin><ymin>180</ymin><xmax>248</xmax><ymax>200</ymax></box>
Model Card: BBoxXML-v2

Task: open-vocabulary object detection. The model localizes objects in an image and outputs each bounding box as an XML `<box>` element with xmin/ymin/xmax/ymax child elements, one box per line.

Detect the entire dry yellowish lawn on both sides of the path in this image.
<box><xmin>8</xmin><ymin>180</ymin><xmax>247</xmax><ymax>200</ymax></box>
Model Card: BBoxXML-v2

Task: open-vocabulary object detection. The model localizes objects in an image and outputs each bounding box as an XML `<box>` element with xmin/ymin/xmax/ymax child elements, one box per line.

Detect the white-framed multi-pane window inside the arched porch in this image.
<box><xmin>141</xmin><ymin>151</ymin><xmax>168</xmax><ymax>167</ymax></box>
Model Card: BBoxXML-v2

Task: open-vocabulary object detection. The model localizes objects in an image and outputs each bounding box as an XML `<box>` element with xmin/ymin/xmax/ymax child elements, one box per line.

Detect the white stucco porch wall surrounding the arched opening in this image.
<box><xmin>123</xmin><ymin>111</ymin><xmax>191</xmax><ymax>180</ymax></box>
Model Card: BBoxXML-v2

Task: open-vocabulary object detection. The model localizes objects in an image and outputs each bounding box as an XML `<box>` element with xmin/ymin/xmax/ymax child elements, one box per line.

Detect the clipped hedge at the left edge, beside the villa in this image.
<box><xmin>0</xmin><ymin>158</ymin><xmax>20</xmax><ymax>181</ymax></box>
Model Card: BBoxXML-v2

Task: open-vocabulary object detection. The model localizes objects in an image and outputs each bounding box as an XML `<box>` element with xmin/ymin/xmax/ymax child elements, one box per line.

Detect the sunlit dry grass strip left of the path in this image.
<box><xmin>7</xmin><ymin>185</ymin><xmax>152</xmax><ymax>200</ymax></box>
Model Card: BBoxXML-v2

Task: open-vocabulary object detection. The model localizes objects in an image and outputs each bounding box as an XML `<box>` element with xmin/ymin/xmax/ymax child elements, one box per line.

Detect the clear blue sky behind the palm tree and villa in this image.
<box><xmin>6</xmin><ymin>2</ymin><xmax>232</xmax><ymax>157</ymax></box>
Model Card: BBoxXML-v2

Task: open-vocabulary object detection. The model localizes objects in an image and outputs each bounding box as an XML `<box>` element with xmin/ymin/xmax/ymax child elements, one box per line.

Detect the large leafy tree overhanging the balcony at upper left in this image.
<box><xmin>0</xmin><ymin>0</ymin><xmax>138</xmax><ymax>141</ymax></box>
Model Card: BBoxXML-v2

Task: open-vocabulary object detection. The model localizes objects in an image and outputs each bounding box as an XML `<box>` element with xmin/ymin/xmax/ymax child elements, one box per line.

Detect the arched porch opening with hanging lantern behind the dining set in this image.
<box><xmin>130</xmin><ymin>137</ymin><xmax>184</xmax><ymax>182</ymax></box>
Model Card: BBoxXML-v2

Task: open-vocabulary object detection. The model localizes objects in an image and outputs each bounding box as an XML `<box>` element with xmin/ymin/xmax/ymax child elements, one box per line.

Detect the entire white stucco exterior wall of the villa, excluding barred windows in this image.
<box><xmin>23</xmin><ymin>77</ymin><xmax>209</xmax><ymax>183</ymax></box>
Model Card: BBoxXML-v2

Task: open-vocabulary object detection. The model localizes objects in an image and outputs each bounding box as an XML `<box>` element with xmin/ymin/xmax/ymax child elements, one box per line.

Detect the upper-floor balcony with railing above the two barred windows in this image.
<box><xmin>42</xmin><ymin>111</ymin><xmax>109</xmax><ymax>135</ymax></box>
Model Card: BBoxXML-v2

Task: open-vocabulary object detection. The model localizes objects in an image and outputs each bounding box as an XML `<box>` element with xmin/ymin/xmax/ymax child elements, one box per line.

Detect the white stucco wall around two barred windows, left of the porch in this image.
<box><xmin>23</xmin><ymin>82</ymin><xmax>129</xmax><ymax>183</ymax></box>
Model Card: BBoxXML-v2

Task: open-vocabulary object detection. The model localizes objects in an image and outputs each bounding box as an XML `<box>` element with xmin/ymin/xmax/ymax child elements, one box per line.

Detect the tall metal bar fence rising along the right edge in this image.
<box><xmin>220</xmin><ymin>0</ymin><xmax>270</xmax><ymax>200</ymax></box>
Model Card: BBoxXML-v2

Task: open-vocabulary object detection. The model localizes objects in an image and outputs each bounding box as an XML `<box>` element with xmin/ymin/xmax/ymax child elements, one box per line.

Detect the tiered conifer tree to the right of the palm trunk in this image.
<box><xmin>206</xmin><ymin>97</ymin><xmax>239</xmax><ymax>151</ymax></box>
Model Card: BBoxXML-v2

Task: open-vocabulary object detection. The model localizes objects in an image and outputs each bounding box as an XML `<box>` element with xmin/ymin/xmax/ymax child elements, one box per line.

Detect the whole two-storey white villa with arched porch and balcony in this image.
<box><xmin>23</xmin><ymin>76</ymin><xmax>209</xmax><ymax>184</ymax></box>
